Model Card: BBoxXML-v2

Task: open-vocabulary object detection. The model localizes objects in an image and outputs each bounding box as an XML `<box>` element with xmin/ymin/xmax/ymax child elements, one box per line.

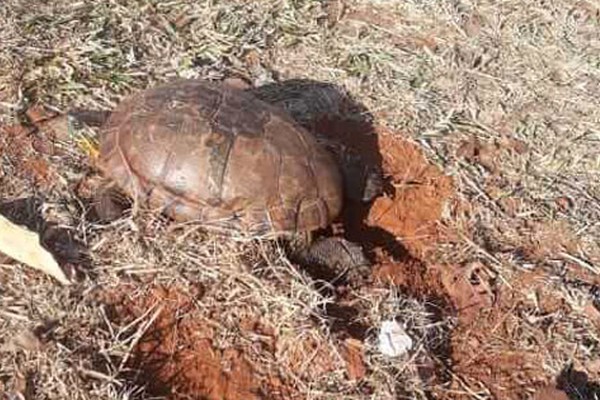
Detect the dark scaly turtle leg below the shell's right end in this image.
<box><xmin>294</xmin><ymin>237</ymin><xmax>371</xmax><ymax>286</ymax></box>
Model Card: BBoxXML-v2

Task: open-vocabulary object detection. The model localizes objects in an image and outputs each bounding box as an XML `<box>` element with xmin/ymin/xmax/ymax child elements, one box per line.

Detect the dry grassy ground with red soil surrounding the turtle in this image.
<box><xmin>0</xmin><ymin>0</ymin><xmax>600</xmax><ymax>399</ymax></box>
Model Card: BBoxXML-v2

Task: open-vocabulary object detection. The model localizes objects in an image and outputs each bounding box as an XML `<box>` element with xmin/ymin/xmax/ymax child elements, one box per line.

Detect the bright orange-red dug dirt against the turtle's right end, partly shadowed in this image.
<box><xmin>316</xmin><ymin>119</ymin><xmax>453</xmax><ymax>258</ymax></box>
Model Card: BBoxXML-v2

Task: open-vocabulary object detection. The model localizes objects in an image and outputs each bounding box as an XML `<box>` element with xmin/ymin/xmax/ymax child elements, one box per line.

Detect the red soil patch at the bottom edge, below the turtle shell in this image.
<box><xmin>104</xmin><ymin>286</ymin><xmax>293</xmax><ymax>400</ymax></box>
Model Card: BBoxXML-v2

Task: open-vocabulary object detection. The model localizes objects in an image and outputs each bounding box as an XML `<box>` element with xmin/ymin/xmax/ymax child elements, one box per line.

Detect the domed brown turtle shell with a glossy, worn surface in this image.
<box><xmin>99</xmin><ymin>80</ymin><xmax>342</xmax><ymax>234</ymax></box>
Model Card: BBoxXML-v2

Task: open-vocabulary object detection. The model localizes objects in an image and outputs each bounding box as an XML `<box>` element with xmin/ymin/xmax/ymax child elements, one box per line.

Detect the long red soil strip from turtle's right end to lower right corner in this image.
<box><xmin>317</xmin><ymin>119</ymin><xmax>580</xmax><ymax>399</ymax></box>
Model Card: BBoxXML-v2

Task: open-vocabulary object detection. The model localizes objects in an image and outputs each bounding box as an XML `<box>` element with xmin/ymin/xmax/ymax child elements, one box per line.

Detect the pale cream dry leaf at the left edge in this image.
<box><xmin>0</xmin><ymin>215</ymin><xmax>71</xmax><ymax>285</ymax></box>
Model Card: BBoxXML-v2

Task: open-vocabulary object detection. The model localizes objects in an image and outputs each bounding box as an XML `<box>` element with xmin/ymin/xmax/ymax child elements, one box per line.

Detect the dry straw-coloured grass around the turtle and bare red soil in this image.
<box><xmin>0</xmin><ymin>0</ymin><xmax>600</xmax><ymax>399</ymax></box>
